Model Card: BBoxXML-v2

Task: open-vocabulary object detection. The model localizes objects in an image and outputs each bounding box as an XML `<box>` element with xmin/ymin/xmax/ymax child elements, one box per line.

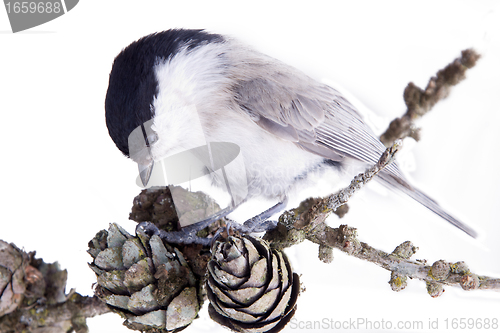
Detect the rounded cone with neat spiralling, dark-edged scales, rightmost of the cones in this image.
<box><xmin>206</xmin><ymin>236</ymin><xmax>300</xmax><ymax>333</ymax></box>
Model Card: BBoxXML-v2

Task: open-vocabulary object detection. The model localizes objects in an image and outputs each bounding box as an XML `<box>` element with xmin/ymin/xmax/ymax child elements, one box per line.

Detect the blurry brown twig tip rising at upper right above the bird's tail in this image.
<box><xmin>380</xmin><ymin>49</ymin><xmax>480</xmax><ymax>146</ymax></box>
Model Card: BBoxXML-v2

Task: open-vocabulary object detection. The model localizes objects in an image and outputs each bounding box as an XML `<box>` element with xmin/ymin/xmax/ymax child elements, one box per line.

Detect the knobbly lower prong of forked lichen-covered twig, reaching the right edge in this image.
<box><xmin>264</xmin><ymin>219</ymin><xmax>500</xmax><ymax>297</ymax></box>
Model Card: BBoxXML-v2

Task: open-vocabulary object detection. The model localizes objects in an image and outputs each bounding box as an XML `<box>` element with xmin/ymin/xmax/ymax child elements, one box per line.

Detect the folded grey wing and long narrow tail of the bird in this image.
<box><xmin>230</xmin><ymin>51</ymin><xmax>476</xmax><ymax>237</ymax></box>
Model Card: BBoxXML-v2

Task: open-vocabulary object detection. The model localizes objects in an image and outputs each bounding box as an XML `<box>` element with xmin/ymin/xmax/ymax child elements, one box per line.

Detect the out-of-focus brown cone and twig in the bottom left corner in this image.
<box><xmin>0</xmin><ymin>240</ymin><xmax>110</xmax><ymax>333</ymax></box>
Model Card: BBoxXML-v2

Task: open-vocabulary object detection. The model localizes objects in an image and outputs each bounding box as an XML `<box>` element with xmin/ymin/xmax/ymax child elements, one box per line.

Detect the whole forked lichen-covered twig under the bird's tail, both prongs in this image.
<box><xmin>264</xmin><ymin>144</ymin><xmax>500</xmax><ymax>297</ymax></box>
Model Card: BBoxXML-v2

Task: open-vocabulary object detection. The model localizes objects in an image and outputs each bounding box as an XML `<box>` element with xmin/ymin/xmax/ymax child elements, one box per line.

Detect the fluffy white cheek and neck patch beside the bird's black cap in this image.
<box><xmin>152</xmin><ymin>44</ymin><xmax>229</xmax><ymax>159</ymax></box>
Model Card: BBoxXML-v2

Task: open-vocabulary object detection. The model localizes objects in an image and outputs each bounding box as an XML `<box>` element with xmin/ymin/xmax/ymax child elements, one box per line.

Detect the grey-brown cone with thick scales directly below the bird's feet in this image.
<box><xmin>88</xmin><ymin>224</ymin><xmax>203</xmax><ymax>333</ymax></box>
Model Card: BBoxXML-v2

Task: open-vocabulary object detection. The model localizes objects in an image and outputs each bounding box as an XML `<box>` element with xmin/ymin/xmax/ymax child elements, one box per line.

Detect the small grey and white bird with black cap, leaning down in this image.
<box><xmin>105</xmin><ymin>29</ymin><xmax>476</xmax><ymax>237</ymax></box>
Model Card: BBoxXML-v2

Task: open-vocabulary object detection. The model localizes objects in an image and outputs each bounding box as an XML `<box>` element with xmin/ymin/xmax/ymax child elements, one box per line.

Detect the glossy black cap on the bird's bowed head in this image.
<box><xmin>105</xmin><ymin>29</ymin><xmax>223</xmax><ymax>185</ymax></box>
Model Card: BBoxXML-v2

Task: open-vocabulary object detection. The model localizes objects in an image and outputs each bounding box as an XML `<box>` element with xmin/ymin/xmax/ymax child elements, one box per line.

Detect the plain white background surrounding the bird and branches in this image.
<box><xmin>0</xmin><ymin>0</ymin><xmax>500</xmax><ymax>333</ymax></box>
